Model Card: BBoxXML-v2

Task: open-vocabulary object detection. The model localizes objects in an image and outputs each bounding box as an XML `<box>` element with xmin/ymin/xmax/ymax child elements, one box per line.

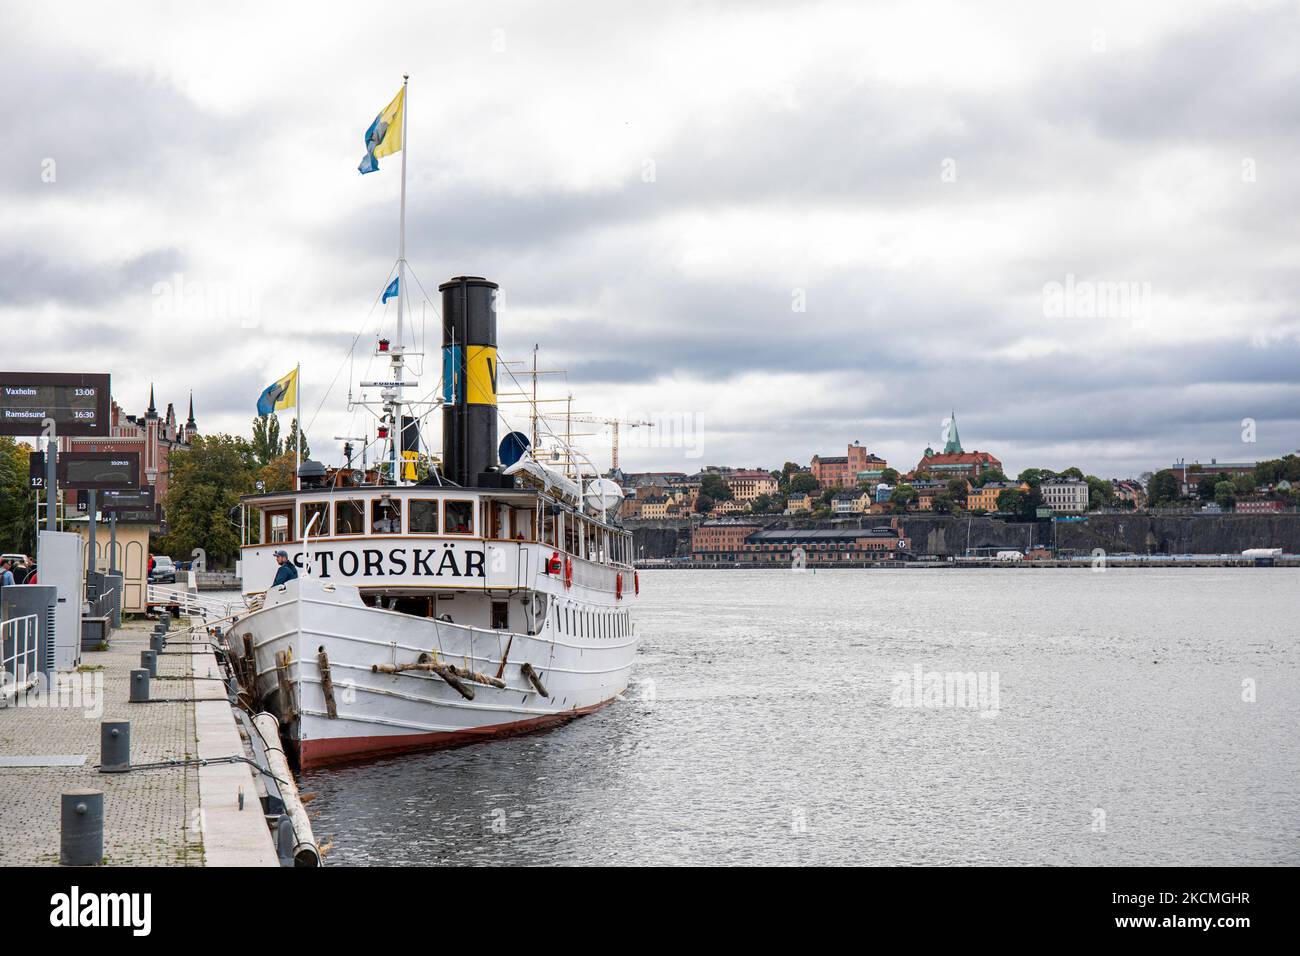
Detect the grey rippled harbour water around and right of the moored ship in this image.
<box><xmin>303</xmin><ymin>568</ymin><xmax>1300</xmax><ymax>865</ymax></box>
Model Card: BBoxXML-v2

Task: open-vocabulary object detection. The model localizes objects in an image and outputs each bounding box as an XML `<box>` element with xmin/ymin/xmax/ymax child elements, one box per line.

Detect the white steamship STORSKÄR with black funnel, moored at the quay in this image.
<box><xmin>235</xmin><ymin>276</ymin><xmax>640</xmax><ymax>769</ymax></box>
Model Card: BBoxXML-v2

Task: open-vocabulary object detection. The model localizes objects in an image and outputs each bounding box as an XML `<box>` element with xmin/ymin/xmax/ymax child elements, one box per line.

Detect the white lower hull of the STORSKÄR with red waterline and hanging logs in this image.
<box><xmin>236</xmin><ymin>578</ymin><xmax>637</xmax><ymax>769</ymax></box>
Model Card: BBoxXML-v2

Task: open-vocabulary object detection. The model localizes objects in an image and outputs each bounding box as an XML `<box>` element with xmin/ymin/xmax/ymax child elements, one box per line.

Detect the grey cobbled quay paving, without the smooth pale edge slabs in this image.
<box><xmin>0</xmin><ymin>620</ymin><xmax>203</xmax><ymax>866</ymax></box>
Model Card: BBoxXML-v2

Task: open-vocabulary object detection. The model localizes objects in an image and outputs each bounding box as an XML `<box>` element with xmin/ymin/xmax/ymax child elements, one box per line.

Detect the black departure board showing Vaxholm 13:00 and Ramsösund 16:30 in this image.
<box><xmin>0</xmin><ymin>372</ymin><xmax>109</xmax><ymax>437</ymax></box>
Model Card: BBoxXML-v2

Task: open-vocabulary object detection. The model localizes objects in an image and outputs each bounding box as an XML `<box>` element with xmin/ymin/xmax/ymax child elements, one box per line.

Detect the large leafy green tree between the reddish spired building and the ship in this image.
<box><xmin>163</xmin><ymin>434</ymin><xmax>254</xmax><ymax>566</ymax></box>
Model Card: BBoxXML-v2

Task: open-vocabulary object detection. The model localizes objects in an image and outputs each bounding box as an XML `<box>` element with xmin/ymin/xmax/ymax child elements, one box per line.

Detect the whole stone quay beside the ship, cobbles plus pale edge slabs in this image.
<box><xmin>0</xmin><ymin>620</ymin><xmax>280</xmax><ymax>866</ymax></box>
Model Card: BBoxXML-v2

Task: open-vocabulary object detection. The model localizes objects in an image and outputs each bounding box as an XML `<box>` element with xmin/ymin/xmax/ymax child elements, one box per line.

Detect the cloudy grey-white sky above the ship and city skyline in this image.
<box><xmin>0</xmin><ymin>0</ymin><xmax>1300</xmax><ymax>476</ymax></box>
